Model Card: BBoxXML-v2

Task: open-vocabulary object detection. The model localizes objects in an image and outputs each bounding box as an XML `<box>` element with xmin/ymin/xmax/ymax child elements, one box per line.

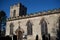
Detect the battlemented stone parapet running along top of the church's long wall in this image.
<box><xmin>7</xmin><ymin>9</ymin><xmax>60</xmax><ymax>21</ymax></box>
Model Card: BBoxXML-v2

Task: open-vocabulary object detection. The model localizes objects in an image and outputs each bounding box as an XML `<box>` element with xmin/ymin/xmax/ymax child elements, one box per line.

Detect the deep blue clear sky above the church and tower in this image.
<box><xmin>0</xmin><ymin>0</ymin><xmax>60</xmax><ymax>17</ymax></box>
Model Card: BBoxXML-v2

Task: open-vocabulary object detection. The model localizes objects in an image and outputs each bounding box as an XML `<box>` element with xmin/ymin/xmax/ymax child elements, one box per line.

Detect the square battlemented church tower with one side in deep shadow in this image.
<box><xmin>10</xmin><ymin>3</ymin><xmax>27</xmax><ymax>17</ymax></box>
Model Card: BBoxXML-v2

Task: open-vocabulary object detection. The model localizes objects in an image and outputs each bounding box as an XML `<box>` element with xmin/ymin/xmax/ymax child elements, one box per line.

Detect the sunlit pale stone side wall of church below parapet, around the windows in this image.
<box><xmin>6</xmin><ymin>13</ymin><xmax>60</xmax><ymax>40</ymax></box>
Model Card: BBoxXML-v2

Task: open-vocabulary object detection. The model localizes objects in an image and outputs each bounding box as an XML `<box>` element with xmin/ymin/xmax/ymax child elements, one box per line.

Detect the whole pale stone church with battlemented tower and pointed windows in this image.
<box><xmin>6</xmin><ymin>3</ymin><xmax>60</xmax><ymax>40</ymax></box>
